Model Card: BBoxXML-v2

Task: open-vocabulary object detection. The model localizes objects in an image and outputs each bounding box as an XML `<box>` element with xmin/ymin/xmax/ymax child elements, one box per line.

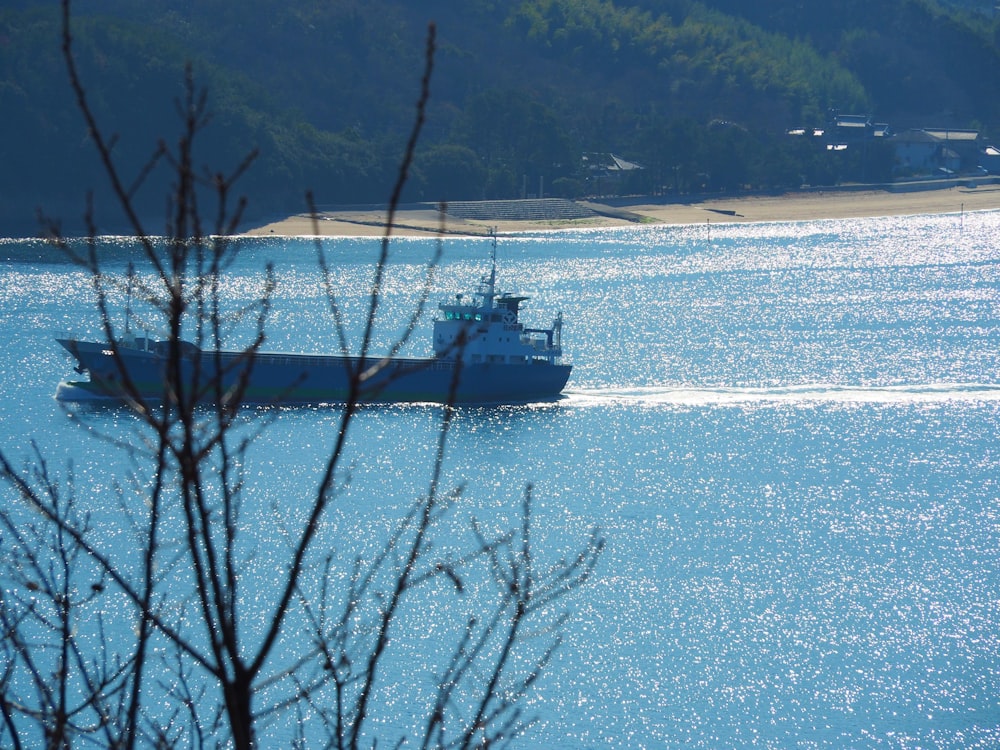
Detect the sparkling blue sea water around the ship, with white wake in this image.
<box><xmin>0</xmin><ymin>212</ymin><xmax>1000</xmax><ymax>748</ymax></box>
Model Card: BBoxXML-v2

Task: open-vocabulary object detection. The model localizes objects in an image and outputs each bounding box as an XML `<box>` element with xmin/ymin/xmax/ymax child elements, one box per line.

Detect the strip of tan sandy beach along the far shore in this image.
<box><xmin>245</xmin><ymin>183</ymin><xmax>1000</xmax><ymax>237</ymax></box>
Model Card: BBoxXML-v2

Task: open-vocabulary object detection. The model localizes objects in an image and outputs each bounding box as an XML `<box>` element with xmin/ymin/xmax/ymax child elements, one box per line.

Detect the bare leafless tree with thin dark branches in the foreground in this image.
<box><xmin>0</xmin><ymin>0</ymin><xmax>603</xmax><ymax>748</ymax></box>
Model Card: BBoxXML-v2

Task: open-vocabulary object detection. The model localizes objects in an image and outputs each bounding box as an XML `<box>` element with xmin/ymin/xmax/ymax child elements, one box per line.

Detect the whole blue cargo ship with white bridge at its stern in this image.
<box><xmin>56</xmin><ymin>245</ymin><xmax>572</xmax><ymax>405</ymax></box>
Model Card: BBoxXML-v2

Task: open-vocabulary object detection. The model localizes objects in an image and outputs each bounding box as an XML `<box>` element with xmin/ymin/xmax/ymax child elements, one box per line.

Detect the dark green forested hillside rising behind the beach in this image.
<box><xmin>0</xmin><ymin>0</ymin><xmax>1000</xmax><ymax>234</ymax></box>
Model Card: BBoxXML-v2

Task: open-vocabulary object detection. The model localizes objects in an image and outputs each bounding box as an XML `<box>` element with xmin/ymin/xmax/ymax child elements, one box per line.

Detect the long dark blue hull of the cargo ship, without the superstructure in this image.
<box><xmin>56</xmin><ymin>339</ymin><xmax>572</xmax><ymax>404</ymax></box>
